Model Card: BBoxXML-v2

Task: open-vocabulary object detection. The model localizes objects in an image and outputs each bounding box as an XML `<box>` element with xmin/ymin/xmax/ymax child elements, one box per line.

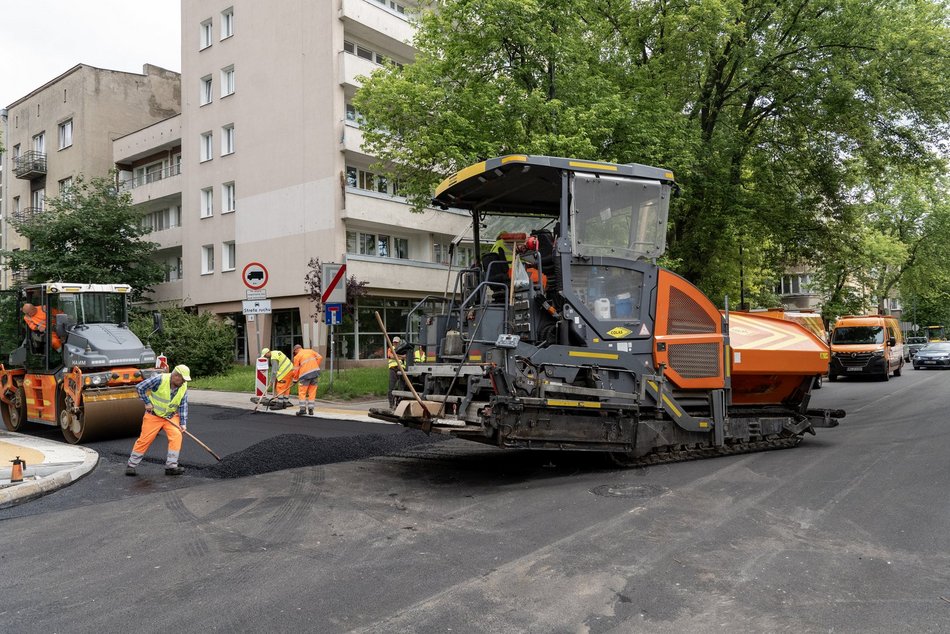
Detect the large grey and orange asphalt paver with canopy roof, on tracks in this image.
<box><xmin>371</xmin><ymin>155</ymin><xmax>844</xmax><ymax>466</ymax></box>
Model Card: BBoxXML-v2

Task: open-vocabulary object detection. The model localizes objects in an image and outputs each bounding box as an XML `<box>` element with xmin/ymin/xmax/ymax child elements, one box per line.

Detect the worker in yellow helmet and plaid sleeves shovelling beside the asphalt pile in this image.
<box><xmin>125</xmin><ymin>365</ymin><xmax>191</xmax><ymax>476</ymax></box>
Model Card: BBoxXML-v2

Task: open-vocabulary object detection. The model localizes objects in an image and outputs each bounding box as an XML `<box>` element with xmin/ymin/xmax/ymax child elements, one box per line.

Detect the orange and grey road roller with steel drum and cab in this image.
<box><xmin>0</xmin><ymin>283</ymin><xmax>163</xmax><ymax>443</ymax></box>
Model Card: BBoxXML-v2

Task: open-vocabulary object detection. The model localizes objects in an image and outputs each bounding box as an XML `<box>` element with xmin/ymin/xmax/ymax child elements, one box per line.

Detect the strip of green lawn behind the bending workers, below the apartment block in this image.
<box><xmin>188</xmin><ymin>365</ymin><xmax>389</xmax><ymax>401</ymax></box>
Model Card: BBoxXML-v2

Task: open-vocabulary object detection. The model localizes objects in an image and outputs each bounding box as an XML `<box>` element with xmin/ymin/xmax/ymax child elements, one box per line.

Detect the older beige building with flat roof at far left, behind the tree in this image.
<box><xmin>0</xmin><ymin>64</ymin><xmax>181</xmax><ymax>288</ymax></box>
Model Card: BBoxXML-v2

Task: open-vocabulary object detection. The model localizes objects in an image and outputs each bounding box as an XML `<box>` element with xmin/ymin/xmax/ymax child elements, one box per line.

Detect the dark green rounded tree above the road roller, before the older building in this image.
<box><xmin>2</xmin><ymin>177</ymin><xmax>165</xmax><ymax>299</ymax></box>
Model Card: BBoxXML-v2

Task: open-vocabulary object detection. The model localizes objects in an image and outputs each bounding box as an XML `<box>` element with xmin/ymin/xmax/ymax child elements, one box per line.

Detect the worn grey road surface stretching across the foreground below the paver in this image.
<box><xmin>0</xmin><ymin>371</ymin><xmax>950</xmax><ymax>633</ymax></box>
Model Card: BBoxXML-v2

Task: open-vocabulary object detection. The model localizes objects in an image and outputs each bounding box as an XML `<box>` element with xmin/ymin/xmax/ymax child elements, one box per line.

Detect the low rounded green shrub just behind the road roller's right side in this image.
<box><xmin>130</xmin><ymin>308</ymin><xmax>234</xmax><ymax>377</ymax></box>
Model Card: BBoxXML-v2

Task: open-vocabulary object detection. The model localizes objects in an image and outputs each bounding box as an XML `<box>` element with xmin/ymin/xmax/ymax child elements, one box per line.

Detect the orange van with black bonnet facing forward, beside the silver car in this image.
<box><xmin>828</xmin><ymin>315</ymin><xmax>904</xmax><ymax>381</ymax></box>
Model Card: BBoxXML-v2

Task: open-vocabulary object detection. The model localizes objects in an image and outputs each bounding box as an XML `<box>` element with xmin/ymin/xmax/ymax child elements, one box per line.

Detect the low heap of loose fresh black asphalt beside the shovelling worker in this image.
<box><xmin>202</xmin><ymin>429</ymin><xmax>445</xmax><ymax>478</ymax></box>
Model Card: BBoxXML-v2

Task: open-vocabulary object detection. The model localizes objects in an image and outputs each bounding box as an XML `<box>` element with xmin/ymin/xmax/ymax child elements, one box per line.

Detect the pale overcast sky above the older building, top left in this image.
<box><xmin>0</xmin><ymin>0</ymin><xmax>181</xmax><ymax>108</ymax></box>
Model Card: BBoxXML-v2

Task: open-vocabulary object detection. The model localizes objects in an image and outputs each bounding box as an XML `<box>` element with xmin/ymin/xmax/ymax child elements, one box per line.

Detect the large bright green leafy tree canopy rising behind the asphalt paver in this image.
<box><xmin>354</xmin><ymin>0</ymin><xmax>950</xmax><ymax>298</ymax></box>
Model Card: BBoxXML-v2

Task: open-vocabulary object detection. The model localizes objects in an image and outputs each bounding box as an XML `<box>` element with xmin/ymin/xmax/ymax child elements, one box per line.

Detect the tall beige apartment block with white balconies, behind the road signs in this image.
<box><xmin>173</xmin><ymin>0</ymin><xmax>471</xmax><ymax>360</ymax></box>
